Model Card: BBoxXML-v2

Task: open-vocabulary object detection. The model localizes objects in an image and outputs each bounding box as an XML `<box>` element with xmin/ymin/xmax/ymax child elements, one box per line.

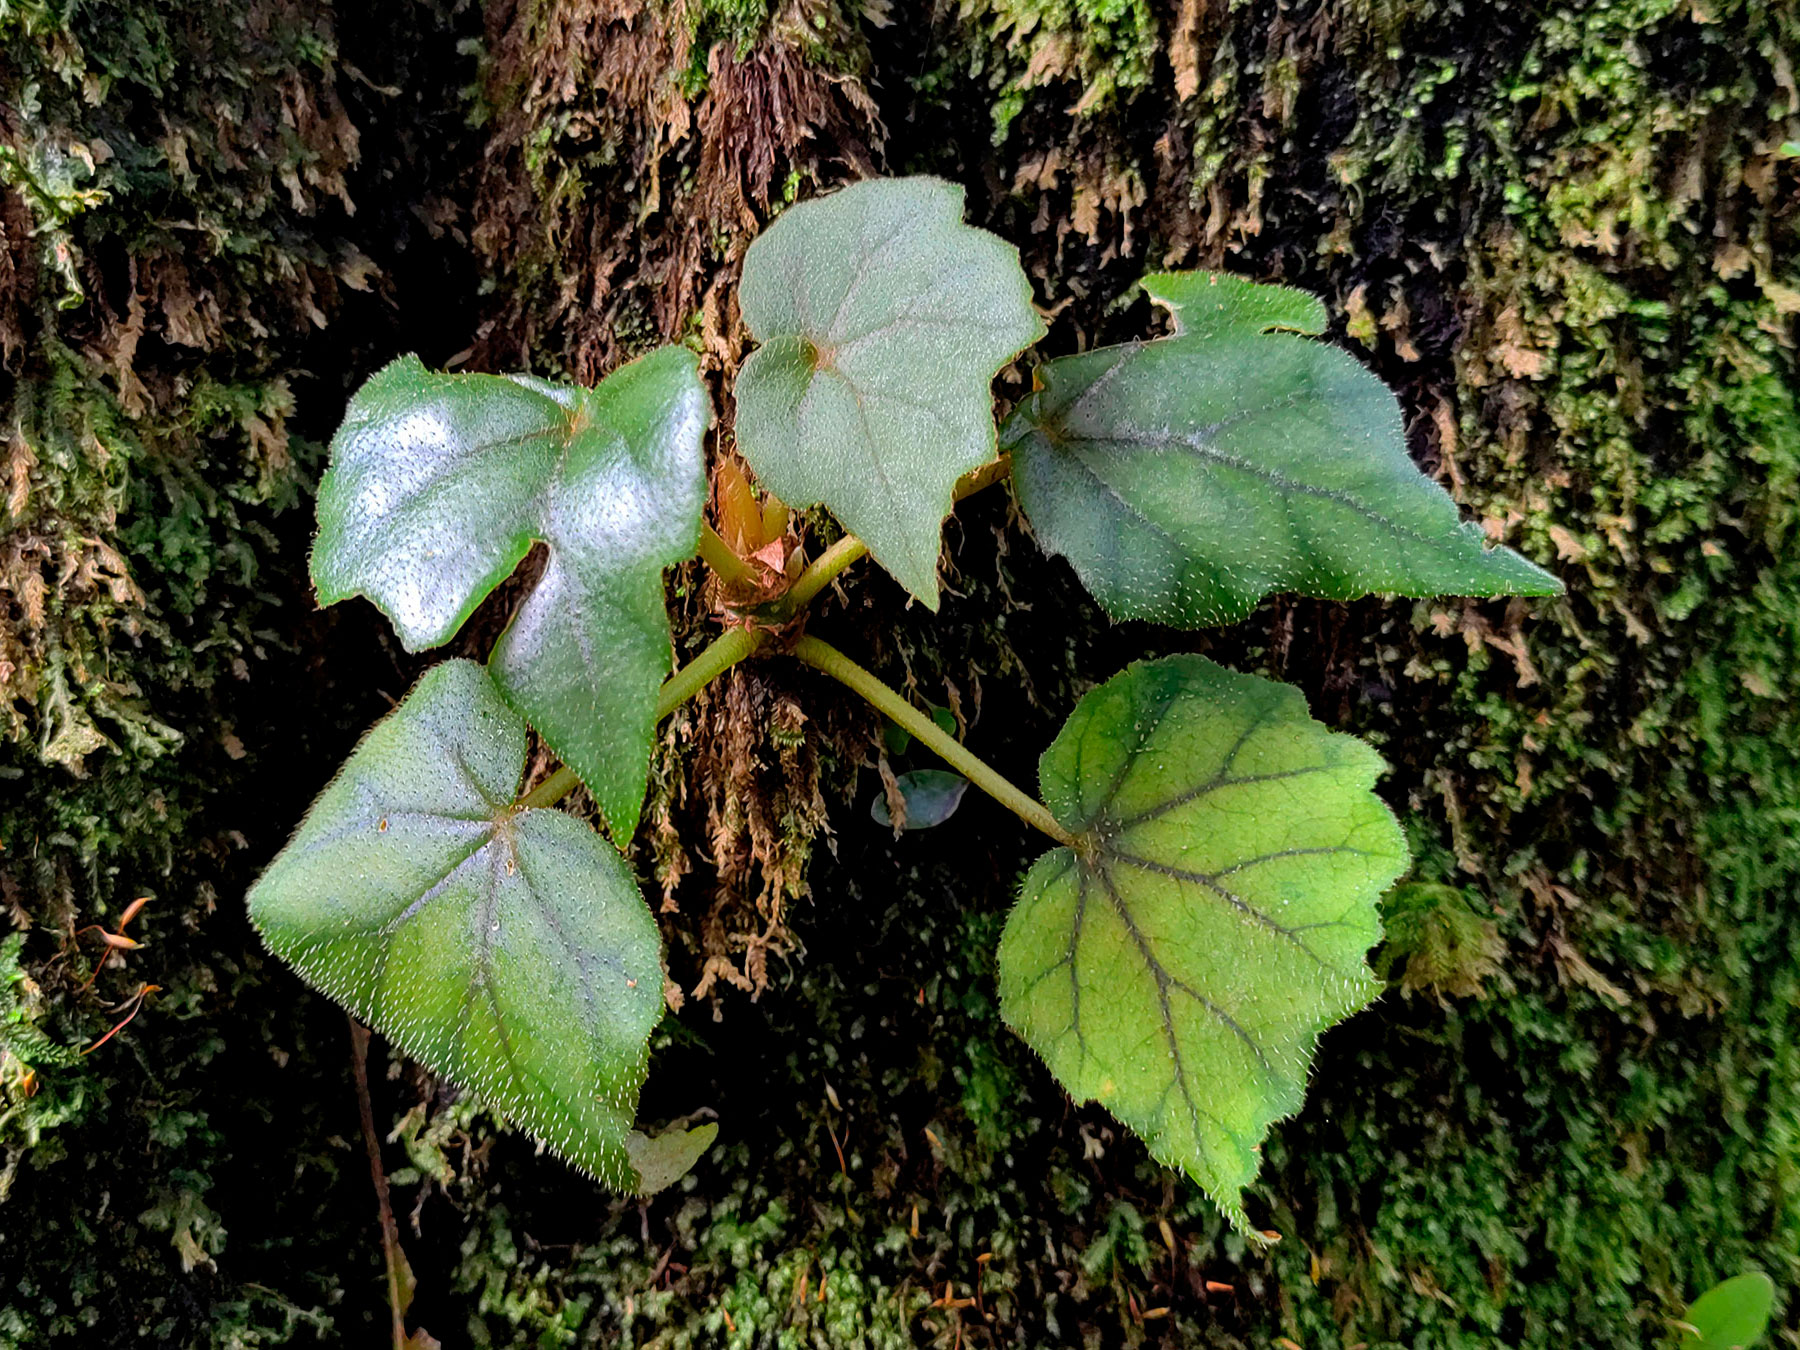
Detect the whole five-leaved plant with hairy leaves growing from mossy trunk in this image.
<box><xmin>250</xmin><ymin>178</ymin><xmax>1559</xmax><ymax>1233</ymax></box>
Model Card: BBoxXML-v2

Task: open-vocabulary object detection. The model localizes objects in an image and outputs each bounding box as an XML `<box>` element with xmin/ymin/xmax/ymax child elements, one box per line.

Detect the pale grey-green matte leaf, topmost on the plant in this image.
<box><xmin>736</xmin><ymin>178</ymin><xmax>1044</xmax><ymax>608</ymax></box>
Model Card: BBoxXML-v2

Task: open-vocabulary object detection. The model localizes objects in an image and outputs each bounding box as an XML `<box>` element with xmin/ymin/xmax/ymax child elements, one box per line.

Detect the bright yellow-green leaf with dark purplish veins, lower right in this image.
<box><xmin>999</xmin><ymin>655</ymin><xmax>1406</xmax><ymax>1231</ymax></box>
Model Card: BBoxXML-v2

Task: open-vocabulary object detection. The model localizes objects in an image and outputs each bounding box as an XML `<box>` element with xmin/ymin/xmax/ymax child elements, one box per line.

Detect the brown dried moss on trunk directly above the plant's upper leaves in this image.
<box><xmin>470</xmin><ymin>0</ymin><xmax>882</xmax><ymax>383</ymax></box>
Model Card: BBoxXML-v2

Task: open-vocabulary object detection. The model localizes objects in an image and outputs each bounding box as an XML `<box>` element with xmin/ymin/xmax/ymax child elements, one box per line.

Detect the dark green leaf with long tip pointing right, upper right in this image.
<box><xmin>1003</xmin><ymin>272</ymin><xmax>1561</xmax><ymax>628</ymax></box>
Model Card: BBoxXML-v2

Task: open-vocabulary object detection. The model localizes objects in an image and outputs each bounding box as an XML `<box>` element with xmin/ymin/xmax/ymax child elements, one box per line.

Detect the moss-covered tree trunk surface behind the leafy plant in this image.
<box><xmin>0</xmin><ymin>0</ymin><xmax>1800</xmax><ymax>1350</ymax></box>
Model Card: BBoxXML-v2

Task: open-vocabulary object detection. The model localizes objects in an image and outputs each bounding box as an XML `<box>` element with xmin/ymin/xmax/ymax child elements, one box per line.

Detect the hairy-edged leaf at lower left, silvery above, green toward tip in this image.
<box><xmin>250</xmin><ymin>661</ymin><xmax>662</xmax><ymax>1190</ymax></box>
